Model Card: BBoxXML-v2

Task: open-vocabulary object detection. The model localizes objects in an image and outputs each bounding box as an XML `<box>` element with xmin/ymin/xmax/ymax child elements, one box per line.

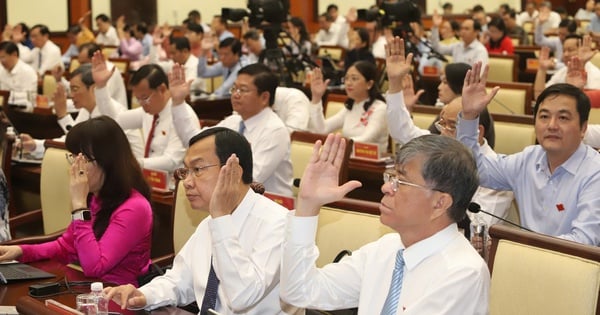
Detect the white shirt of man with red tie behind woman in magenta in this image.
<box><xmin>96</xmin><ymin>87</ymin><xmax>189</xmax><ymax>172</ymax></box>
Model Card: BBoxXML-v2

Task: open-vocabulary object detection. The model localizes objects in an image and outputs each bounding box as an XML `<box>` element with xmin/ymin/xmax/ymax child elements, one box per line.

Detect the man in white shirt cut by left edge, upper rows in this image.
<box><xmin>0</xmin><ymin>41</ymin><xmax>37</xmax><ymax>99</ymax></box>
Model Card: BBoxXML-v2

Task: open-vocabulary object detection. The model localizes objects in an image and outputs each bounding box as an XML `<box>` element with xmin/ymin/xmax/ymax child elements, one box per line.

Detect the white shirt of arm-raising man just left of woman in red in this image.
<box><xmin>429</xmin><ymin>27</ymin><xmax>489</xmax><ymax>66</ymax></box>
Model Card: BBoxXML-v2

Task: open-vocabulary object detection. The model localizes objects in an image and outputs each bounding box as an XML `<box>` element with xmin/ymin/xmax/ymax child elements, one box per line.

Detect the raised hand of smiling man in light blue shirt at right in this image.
<box><xmin>462</xmin><ymin>61</ymin><xmax>500</xmax><ymax>120</ymax></box>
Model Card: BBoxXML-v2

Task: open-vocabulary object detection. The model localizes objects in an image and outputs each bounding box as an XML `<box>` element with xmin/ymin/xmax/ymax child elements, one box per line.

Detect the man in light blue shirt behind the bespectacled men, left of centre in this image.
<box><xmin>198</xmin><ymin>37</ymin><xmax>248</xmax><ymax>96</ymax></box>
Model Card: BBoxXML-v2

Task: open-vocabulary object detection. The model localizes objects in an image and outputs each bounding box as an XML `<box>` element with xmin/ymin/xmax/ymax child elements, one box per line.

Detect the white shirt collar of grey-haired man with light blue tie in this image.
<box><xmin>402</xmin><ymin>223</ymin><xmax>463</xmax><ymax>270</ymax></box>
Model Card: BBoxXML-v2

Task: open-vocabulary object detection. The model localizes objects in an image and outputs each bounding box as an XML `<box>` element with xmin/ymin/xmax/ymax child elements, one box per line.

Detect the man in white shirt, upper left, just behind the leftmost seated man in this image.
<box><xmin>29</xmin><ymin>24</ymin><xmax>64</xmax><ymax>77</ymax></box>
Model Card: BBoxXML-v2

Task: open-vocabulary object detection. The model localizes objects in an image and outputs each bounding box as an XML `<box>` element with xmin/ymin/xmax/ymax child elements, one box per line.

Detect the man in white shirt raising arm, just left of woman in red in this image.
<box><xmin>431</xmin><ymin>11</ymin><xmax>488</xmax><ymax>65</ymax></box>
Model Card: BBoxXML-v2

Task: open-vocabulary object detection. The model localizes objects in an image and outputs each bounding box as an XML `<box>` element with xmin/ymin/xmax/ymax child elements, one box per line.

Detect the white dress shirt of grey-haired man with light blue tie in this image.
<box><xmin>281</xmin><ymin>218</ymin><xmax>490</xmax><ymax>315</ymax></box>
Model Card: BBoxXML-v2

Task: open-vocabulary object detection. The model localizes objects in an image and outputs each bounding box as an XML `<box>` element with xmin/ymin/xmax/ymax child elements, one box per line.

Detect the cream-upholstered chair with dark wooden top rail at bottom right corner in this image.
<box><xmin>488</xmin><ymin>225</ymin><xmax>600</xmax><ymax>315</ymax></box>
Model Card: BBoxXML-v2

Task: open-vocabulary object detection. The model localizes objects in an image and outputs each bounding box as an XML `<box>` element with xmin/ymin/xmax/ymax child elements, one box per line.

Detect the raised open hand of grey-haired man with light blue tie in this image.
<box><xmin>296</xmin><ymin>134</ymin><xmax>362</xmax><ymax>216</ymax></box>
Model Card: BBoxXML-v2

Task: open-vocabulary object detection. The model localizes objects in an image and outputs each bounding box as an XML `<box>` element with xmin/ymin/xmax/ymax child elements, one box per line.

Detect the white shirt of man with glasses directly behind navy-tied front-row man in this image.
<box><xmin>173</xmin><ymin>104</ymin><xmax>293</xmax><ymax>196</ymax></box>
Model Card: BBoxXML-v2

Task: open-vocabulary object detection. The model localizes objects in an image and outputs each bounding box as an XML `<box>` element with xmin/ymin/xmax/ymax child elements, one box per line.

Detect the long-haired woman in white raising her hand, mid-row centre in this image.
<box><xmin>309</xmin><ymin>61</ymin><xmax>388</xmax><ymax>153</ymax></box>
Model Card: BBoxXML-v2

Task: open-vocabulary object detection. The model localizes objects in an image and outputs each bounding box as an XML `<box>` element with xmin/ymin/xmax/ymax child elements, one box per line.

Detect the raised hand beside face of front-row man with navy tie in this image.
<box><xmin>208</xmin><ymin>154</ymin><xmax>244</xmax><ymax>218</ymax></box>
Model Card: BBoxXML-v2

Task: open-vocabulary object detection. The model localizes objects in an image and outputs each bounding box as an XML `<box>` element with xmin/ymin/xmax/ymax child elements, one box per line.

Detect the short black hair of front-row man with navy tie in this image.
<box><xmin>189</xmin><ymin>127</ymin><xmax>253</xmax><ymax>184</ymax></box>
